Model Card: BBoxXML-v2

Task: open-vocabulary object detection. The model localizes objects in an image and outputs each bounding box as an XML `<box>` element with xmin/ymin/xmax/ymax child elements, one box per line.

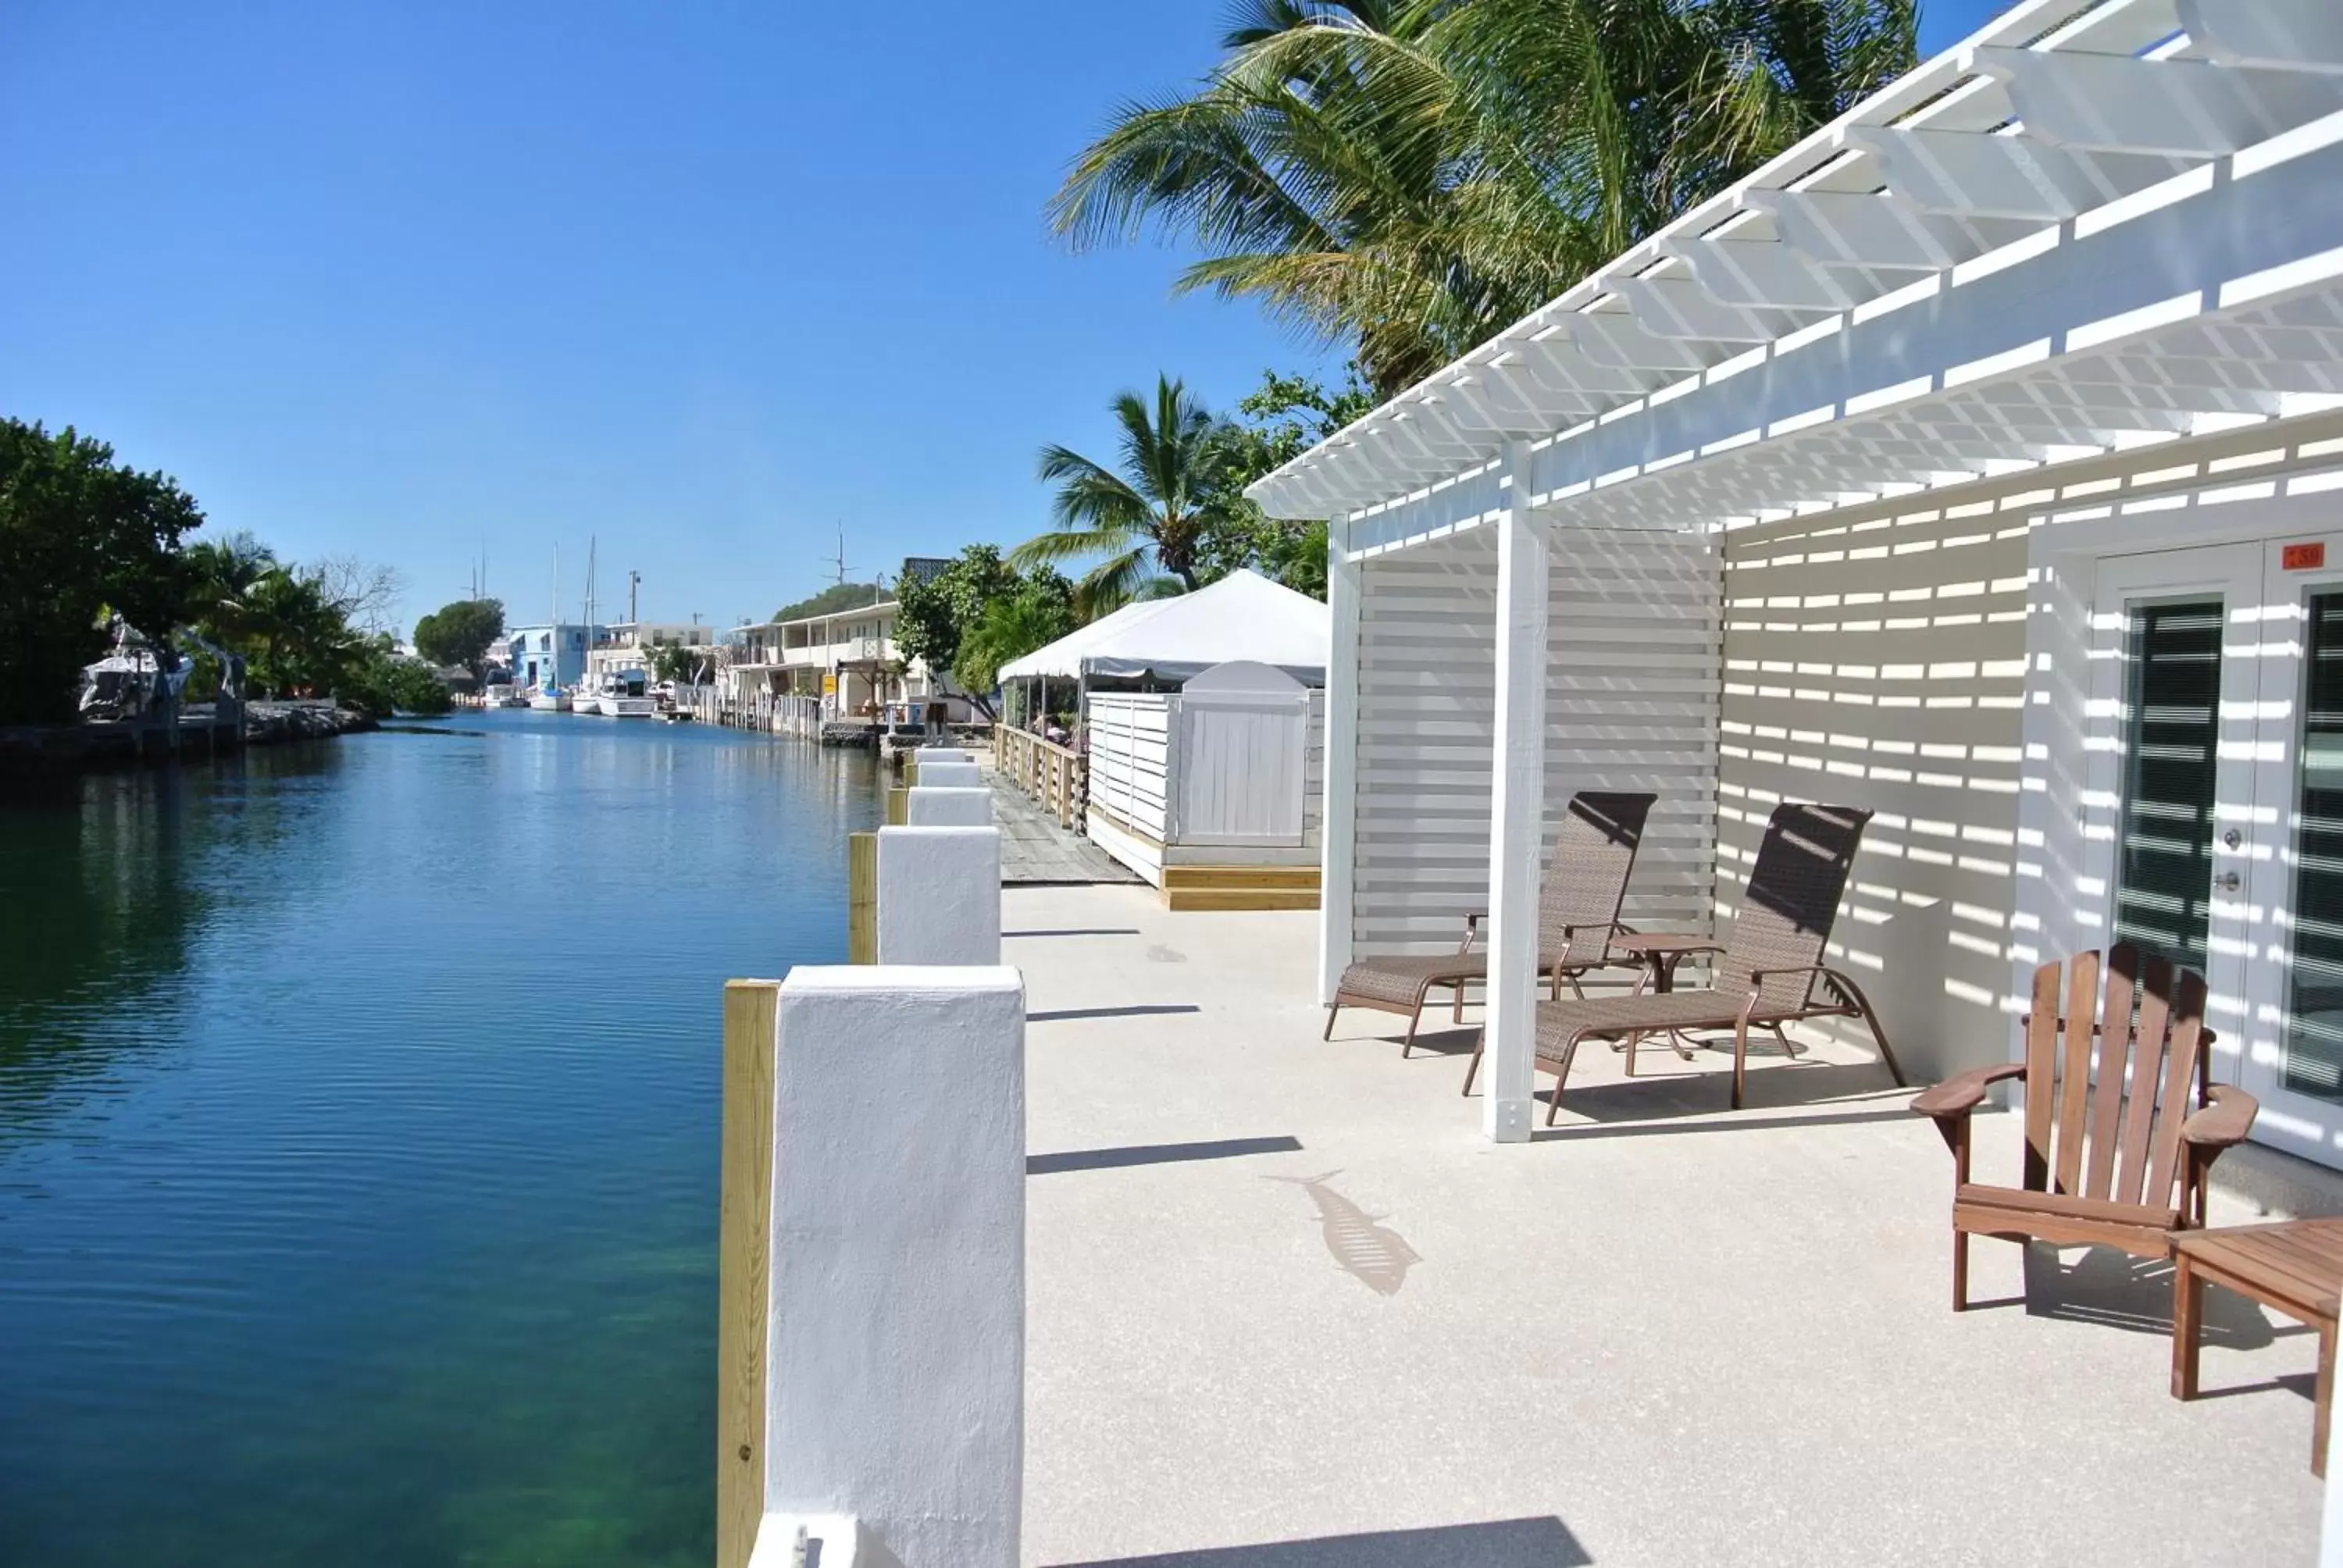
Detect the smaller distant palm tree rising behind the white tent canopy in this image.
<box><xmin>1010</xmin><ymin>375</ymin><xmax>1221</xmax><ymax>621</ymax></box>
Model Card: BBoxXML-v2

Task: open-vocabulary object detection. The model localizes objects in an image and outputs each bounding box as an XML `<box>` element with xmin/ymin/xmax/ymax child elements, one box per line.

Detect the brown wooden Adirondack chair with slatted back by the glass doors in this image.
<box><xmin>1912</xmin><ymin>943</ymin><xmax>2261</xmax><ymax>1313</ymax></box>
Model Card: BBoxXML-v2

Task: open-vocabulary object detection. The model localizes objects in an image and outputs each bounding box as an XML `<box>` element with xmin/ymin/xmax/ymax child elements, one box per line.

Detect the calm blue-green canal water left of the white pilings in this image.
<box><xmin>0</xmin><ymin>712</ymin><xmax>879</xmax><ymax>1568</ymax></box>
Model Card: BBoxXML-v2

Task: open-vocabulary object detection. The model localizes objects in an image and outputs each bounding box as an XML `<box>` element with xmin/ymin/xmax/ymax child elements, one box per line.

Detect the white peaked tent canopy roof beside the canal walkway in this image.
<box><xmin>1000</xmin><ymin>572</ymin><xmax>1333</xmax><ymax>686</ymax></box>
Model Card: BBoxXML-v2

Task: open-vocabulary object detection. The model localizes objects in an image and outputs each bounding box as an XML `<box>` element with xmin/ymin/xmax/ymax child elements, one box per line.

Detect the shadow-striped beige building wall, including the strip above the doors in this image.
<box><xmin>1717</xmin><ymin>417</ymin><xmax>2343</xmax><ymax>1081</ymax></box>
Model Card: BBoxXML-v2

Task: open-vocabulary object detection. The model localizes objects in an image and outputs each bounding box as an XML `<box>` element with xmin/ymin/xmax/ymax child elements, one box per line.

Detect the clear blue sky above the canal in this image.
<box><xmin>0</xmin><ymin>0</ymin><xmax>1996</xmax><ymax>623</ymax></box>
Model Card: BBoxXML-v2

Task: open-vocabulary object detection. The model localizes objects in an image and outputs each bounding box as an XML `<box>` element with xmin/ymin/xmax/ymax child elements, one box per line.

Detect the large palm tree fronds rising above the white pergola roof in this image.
<box><xmin>1050</xmin><ymin>0</ymin><xmax>1917</xmax><ymax>396</ymax></box>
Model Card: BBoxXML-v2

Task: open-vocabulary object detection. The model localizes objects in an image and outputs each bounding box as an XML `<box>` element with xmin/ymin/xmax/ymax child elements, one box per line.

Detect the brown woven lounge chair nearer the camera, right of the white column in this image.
<box><xmin>1464</xmin><ymin>804</ymin><xmax>1905</xmax><ymax>1125</ymax></box>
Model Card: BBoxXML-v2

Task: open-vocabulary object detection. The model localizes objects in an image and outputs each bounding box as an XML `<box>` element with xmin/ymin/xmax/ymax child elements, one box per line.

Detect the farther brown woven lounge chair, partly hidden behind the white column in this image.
<box><xmin>1319</xmin><ymin>790</ymin><xmax>1659</xmax><ymax>1055</ymax></box>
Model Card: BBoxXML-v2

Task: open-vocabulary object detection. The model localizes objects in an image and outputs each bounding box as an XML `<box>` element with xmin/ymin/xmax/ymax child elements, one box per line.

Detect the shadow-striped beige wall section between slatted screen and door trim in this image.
<box><xmin>1717</xmin><ymin>501</ymin><xmax>2027</xmax><ymax>1081</ymax></box>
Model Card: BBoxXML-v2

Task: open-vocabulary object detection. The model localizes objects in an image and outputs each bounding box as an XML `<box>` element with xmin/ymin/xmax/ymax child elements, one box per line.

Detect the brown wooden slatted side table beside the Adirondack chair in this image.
<box><xmin>2172</xmin><ymin>1219</ymin><xmax>2343</xmax><ymax>1477</ymax></box>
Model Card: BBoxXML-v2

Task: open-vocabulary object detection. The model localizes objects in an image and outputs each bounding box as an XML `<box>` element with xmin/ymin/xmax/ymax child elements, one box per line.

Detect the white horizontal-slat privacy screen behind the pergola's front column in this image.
<box><xmin>1352</xmin><ymin>527</ymin><xmax>1720</xmax><ymax>954</ymax></box>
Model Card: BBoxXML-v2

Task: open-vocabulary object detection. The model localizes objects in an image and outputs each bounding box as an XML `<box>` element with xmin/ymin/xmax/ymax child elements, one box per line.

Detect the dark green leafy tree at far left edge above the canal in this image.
<box><xmin>0</xmin><ymin>419</ymin><xmax>204</xmax><ymax>724</ymax></box>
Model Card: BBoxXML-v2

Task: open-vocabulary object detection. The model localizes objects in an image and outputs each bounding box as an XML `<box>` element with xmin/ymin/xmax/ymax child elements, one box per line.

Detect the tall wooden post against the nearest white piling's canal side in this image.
<box><xmin>717</xmin><ymin>980</ymin><xmax>780</xmax><ymax>1568</ymax></box>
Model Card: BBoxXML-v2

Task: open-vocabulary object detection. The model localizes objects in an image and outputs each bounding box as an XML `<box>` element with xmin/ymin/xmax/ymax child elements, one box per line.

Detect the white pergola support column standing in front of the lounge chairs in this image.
<box><xmin>1481</xmin><ymin>440</ymin><xmax>1549</xmax><ymax>1144</ymax></box>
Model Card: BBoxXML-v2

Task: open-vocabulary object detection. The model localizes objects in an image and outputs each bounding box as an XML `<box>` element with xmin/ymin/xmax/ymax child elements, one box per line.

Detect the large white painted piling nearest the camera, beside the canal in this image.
<box><xmin>752</xmin><ymin>965</ymin><xmax>1026</xmax><ymax>1568</ymax></box>
